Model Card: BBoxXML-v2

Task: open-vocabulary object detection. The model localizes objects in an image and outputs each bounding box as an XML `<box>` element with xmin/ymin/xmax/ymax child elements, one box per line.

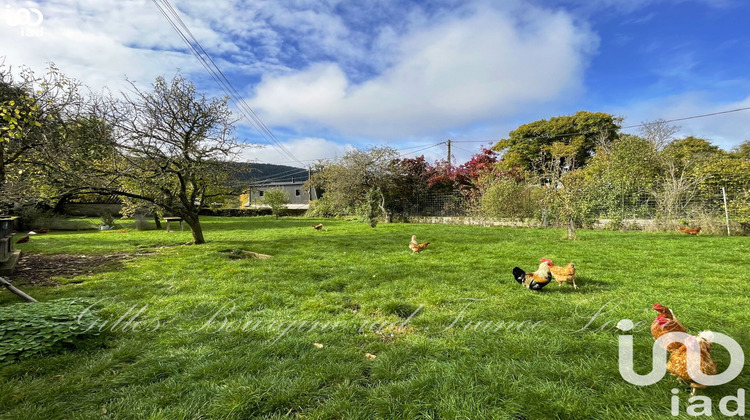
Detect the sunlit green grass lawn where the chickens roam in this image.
<box><xmin>0</xmin><ymin>218</ymin><xmax>750</xmax><ymax>419</ymax></box>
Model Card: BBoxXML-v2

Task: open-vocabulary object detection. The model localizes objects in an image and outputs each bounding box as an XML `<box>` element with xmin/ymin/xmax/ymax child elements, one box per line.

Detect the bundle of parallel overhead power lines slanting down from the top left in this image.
<box><xmin>152</xmin><ymin>0</ymin><xmax>302</xmax><ymax>164</ymax></box>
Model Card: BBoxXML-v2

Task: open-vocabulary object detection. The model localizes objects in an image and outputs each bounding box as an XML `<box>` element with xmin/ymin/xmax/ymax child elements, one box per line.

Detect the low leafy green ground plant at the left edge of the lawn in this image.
<box><xmin>0</xmin><ymin>299</ymin><xmax>99</xmax><ymax>364</ymax></box>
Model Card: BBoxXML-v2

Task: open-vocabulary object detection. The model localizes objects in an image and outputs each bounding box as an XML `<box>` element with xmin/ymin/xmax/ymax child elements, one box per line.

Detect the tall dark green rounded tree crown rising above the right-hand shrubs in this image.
<box><xmin>492</xmin><ymin>111</ymin><xmax>622</xmax><ymax>172</ymax></box>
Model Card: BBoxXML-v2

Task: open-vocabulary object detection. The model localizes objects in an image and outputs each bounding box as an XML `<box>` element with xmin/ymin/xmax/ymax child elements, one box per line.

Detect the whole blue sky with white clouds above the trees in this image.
<box><xmin>0</xmin><ymin>0</ymin><xmax>750</xmax><ymax>166</ymax></box>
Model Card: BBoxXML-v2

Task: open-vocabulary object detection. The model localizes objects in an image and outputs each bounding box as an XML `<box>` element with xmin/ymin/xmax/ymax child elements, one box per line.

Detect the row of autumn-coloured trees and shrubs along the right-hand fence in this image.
<box><xmin>310</xmin><ymin>111</ymin><xmax>750</xmax><ymax>237</ymax></box>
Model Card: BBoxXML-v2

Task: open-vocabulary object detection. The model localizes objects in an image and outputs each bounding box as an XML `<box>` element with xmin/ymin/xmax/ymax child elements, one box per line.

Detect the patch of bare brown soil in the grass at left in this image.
<box><xmin>8</xmin><ymin>252</ymin><xmax>145</xmax><ymax>287</ymax></box>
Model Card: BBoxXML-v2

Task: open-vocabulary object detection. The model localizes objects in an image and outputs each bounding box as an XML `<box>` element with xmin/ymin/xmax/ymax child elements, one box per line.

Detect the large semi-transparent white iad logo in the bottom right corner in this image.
<box><xmin>618</xmin><ymin>319</ymin><xmax>745</xmax><ymax>416</ymax></box>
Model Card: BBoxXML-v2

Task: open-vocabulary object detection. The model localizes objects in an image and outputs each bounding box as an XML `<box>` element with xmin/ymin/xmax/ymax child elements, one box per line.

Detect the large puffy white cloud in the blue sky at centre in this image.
<box><xmin>250</xmin><ymin>4</ymin><xmax>596</xmax><ymax>138</ymax></box>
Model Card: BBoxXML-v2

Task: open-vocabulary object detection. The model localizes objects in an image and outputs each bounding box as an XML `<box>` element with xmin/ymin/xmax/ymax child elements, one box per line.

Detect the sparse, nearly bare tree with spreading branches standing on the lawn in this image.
<box><xmin>47</xmin><ymin>75</ymin><xmax>239</xmax><ymax>244</ymax></box>
